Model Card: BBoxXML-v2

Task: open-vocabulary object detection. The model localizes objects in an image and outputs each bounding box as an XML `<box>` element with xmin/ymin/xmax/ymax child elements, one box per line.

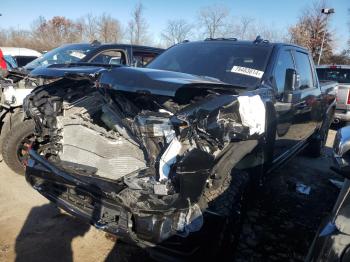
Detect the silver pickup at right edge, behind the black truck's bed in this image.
<box><xmin>317</xmin><ymin>65</ymin><xmax>350</xmax><ymax>123</ymax></box>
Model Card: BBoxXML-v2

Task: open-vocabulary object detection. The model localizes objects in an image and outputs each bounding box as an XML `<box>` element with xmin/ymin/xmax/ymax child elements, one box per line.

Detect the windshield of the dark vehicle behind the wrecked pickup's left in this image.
<box><xmin>25</xmin><ymin>44</ymin><xmax>96</xmax><ymax>69</ymax></box>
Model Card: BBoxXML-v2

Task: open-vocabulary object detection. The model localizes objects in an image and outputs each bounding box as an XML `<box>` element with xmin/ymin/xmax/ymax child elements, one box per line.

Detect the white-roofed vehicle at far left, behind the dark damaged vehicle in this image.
<box><xmin>0</xmin><ymin>47</ymin><xmax>41</xmax><ymax>67</ymax></box>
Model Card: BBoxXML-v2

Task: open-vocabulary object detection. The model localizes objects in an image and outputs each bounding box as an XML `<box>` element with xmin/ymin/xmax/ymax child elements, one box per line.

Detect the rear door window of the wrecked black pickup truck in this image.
<box><xmin>295</xmin><ymin>51</ymin><xmax>314</xmax><ymax>89</ymax></box>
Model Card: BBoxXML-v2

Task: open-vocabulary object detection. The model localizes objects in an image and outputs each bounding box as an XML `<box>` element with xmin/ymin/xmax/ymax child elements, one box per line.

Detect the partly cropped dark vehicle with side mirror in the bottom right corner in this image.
<box><xmin>306</xmin><ymin>127</ymin><xmax>350</xmax><ymax>262</ymax></box>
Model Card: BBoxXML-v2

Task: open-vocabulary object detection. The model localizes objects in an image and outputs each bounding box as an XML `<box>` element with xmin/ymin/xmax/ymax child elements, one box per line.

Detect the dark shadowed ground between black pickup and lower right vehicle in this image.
<box><xmin>235</xmin><ymin>130</ymin><xmax>341</xmax><ymax>261</ymax></box>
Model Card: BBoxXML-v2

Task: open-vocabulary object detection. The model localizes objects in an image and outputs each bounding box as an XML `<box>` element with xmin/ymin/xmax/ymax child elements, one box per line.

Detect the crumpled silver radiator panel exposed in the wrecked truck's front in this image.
<box><xmin>60</xmin><ymin>124</ymin><xmax>146</xmax><ymax>179</ymax></box>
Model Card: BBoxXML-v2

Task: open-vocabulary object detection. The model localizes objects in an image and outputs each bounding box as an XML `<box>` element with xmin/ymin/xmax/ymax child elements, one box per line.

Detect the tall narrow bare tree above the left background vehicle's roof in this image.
<box><xmin>127</xmin><ymin>3</ymin><xmax>148</xmax><ymax>45</ymax></box>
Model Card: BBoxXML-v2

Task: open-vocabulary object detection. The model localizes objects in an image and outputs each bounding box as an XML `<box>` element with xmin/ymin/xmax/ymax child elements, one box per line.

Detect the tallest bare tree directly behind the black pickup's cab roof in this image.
<box><xmin>198</xmin><ymin>5</ymin><xmax>230</xmax><ymax>38</ymax></box>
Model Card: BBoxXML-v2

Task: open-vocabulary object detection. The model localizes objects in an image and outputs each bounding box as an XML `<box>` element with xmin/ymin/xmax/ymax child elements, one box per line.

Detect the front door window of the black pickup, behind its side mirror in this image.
<box><xmin>274</xmin><ymin>50</ymin><xmax>294</xmax><ymax>93</ymax></box>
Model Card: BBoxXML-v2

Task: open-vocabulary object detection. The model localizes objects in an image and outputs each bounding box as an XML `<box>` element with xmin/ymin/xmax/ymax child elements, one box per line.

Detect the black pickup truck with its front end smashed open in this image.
<box><xmin>24</xmin><ymin>38</ymin><xmax>335</xmax><ymax>260</ymax></box>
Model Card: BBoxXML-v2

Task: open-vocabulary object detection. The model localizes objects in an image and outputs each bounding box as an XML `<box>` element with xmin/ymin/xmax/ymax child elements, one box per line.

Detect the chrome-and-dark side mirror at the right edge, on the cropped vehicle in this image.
<box><xmin>331</xmin><ymin>126</ymin><xmax>350</xmax><ymax>179</ymax></box>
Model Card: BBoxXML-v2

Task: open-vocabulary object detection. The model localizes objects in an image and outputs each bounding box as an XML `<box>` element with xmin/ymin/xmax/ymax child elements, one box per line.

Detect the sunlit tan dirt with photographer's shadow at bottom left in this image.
<box><xmin>0</xmin><ymin>163</ymin><xmax>115</xmax><ymax>262</ymax></box>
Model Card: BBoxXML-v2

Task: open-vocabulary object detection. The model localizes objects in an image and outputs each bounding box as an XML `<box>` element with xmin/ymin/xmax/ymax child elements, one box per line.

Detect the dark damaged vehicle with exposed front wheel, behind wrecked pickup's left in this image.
<box><xmin>0</xmin><ymin>43</ymin><xmax>163</xmax><ymax>174</ymax></box>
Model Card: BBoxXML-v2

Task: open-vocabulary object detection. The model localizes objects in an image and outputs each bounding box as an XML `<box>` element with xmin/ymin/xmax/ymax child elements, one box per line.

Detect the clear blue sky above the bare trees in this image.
<box><xmin>0</xmin><ymin>0</ymin><xmax>350</xmax><ymax>50</ymax></box>
